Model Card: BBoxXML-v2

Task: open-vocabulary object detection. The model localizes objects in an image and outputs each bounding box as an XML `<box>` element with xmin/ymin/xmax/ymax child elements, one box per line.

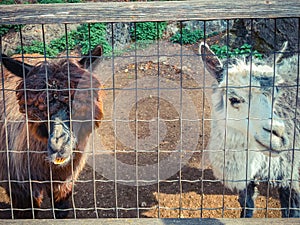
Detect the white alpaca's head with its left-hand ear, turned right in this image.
<box><xmin>199</xmin><ymin>44</ymin><xmax>288</xmax><ymax>156</ymax></box>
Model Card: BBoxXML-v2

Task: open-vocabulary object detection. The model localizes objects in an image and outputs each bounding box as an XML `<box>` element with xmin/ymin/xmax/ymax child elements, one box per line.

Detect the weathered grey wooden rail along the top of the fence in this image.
<box><xmin>0</xmin><ymin>0</ymin><xmax>300</xmax><ymax>24</ymax></box>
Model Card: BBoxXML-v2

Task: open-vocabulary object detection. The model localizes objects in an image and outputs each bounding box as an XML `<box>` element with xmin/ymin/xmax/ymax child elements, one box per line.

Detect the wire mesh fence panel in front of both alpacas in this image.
<box><xmin>0</xmin><ymin>18</ymin><xmax>300</xmax><ymax>219</ymax></box>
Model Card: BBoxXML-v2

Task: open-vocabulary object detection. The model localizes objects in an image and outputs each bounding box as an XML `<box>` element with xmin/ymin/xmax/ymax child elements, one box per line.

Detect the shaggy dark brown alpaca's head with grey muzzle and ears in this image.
<box><xmin>2</xmin><ymin>47</ymin><xmax>103</xmax><ymax>165</ymax></box>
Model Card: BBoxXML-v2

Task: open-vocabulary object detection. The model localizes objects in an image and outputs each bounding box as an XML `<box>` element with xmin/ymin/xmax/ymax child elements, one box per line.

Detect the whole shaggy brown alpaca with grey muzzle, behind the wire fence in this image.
<box><xmin>0</xmin><ymin>47</ymin><xmax>103</xmax><ymax>218</ymax></box>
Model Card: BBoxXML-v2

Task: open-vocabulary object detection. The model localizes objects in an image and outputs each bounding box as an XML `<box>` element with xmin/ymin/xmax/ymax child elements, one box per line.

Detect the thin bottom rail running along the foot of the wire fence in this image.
<box><xmin>0</xmin><ymin>218</ymin><xmax>300</xmax><ymax>225</ymax></box>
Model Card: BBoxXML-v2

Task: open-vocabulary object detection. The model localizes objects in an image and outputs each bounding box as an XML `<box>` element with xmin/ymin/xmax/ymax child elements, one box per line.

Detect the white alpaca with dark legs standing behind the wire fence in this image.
<box><xmin>199</xmin><ymin>43</ymin><xmax>300</xmax><ymax>217</ymax></box>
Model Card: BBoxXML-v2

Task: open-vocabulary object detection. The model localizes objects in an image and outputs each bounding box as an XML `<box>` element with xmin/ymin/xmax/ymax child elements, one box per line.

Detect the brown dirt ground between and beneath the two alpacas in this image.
<box><xmin>0</xmin><ymin>42</ymin><xmax>280</xmax><ymax>218</ymax></box>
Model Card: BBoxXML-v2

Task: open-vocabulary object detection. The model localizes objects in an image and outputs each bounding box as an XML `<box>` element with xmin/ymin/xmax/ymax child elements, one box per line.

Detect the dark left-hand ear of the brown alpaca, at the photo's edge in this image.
<box><xmin>1</xmin><ymin>54</ymin><xmax>33</xmax><ymax>78</ymax></box>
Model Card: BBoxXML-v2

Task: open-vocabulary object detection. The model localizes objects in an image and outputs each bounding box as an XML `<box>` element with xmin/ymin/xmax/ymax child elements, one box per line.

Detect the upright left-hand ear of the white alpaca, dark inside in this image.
<box><xmin>199</xmin><ymin>42</ymin><xmax>223</xmax><ymax>83</ymax></box>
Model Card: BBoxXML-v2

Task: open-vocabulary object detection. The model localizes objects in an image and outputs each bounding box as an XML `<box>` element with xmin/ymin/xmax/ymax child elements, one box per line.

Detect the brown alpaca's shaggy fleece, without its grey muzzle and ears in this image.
<box><xmin>0</xmin><ymin>57</ymin><xmax>103</xmax><ymax>217</ymax></box>
